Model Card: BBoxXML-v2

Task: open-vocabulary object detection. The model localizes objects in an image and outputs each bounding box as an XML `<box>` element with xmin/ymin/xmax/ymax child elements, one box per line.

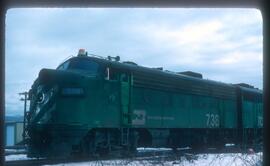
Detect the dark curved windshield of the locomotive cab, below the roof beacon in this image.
<box><xmin>57</xmin><ymin>58</ymin><xmax>99</xmax><ymax>74</ymax></box>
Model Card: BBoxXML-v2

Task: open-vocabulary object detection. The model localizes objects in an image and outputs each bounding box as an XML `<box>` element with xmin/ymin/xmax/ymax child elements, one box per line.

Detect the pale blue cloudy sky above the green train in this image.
<box><xmin>5</xmin><ymin>8</ymin><xmax>263</xmax><ymax>115</ymax></box>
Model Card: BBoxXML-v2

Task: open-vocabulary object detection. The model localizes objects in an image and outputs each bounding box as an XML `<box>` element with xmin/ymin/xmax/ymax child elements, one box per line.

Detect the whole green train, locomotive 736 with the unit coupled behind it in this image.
<box><xmin>26</xmin><ymin>50</ymin><xmax>263</xmax><ymax>157</ymax></box>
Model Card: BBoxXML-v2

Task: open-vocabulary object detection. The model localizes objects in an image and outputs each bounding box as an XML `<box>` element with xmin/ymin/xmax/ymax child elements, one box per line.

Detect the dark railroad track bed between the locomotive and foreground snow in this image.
<box><xmin>5</xmin><ymin>147</ymin><xmax>262</xmax><ymax>166</ymax></box>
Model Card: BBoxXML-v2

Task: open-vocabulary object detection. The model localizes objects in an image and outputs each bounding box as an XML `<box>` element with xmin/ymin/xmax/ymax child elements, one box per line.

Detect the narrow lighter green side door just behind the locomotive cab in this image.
<box><xmin>120</xmin><ymin>73</ymin><xmax>131</xmax><ymax>126</ymax></box>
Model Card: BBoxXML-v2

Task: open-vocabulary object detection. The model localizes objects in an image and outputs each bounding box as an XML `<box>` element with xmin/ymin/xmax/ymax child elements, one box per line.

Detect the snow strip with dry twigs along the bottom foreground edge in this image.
<box><xmin>43</xmin><ymin>152</ymin><xmax>262</xmax><ymax>166</ymax></box>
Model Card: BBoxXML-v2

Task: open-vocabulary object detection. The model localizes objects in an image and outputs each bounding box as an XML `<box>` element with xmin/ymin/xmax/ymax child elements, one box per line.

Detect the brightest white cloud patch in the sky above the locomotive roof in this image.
<box><xmin>135</xmin><ymin>20</ymin><xmax>222</xmax><ymax>47</ymax></box>
